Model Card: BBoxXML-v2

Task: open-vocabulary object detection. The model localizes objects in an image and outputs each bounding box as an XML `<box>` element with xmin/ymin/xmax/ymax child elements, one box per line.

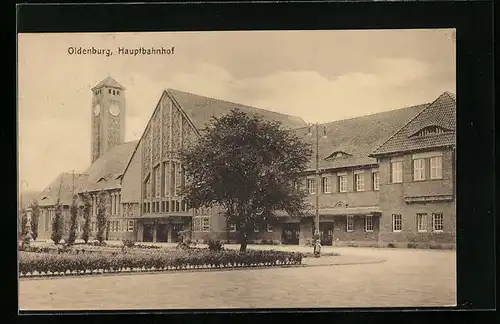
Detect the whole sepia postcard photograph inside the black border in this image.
<box><xmin>17</xmin><ymin>29</ymin><xmax>457</xmax><ymax>311</ymax></box>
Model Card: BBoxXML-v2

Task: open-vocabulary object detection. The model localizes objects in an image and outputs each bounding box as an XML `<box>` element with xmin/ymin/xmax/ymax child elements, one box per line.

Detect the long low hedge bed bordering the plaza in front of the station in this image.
<box><xmin>19</xmin><ymin>249</ymin><xmax>302</xmax><ymax>277</ymax></box>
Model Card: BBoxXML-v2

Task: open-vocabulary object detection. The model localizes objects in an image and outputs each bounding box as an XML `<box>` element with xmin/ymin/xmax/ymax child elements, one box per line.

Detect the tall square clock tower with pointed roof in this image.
<box><xmin>90</xmin><ymin>77</ymin><xmax>125</xmax><ymax>163</ymax></box>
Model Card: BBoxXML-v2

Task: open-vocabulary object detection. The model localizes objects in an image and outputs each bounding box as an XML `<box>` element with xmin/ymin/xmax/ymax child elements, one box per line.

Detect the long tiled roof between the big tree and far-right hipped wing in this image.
<box><xmin>295</xmin><ymin>104</ymin><xmax>427</xmax><ymax>170</ymax></box>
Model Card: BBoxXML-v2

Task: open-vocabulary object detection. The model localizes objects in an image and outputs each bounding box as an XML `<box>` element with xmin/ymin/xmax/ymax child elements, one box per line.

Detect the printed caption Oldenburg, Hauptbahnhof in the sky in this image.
<box><xmin>68</xmin><ymin>46</ymin><xmax>175</xmax><ymax>56</ymax></box>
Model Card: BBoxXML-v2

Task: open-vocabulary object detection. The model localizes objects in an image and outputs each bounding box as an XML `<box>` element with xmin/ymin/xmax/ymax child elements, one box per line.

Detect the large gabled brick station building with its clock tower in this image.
<box><xmin>29</xmin><ymin>77</ymin><xmax>456</xmax><ymax>246</ymax></box>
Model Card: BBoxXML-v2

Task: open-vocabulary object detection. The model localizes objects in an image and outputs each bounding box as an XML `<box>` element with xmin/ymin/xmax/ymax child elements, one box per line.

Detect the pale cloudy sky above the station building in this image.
<box><xmin>17</xmin><ymin>29</ymin><xmax>456</xmax><ymax>190</ymax></box>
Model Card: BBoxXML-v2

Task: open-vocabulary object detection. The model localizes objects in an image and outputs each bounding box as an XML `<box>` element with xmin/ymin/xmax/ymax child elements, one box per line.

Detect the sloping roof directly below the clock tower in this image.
<box><xmin>82</xmin><ymin>140</ymin><xmax>139</xmax><ymax>191</ymax></box>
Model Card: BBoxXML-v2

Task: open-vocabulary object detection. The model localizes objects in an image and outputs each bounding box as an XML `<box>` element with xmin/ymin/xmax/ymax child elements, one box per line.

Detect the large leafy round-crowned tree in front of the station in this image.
<box><xmin>181</xmin><ymin>110</ymin><xmax>312</xmax><ymax>251</ymax></box>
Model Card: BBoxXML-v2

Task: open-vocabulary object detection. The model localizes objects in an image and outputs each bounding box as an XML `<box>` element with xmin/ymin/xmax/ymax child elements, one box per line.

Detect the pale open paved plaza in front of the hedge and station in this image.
<box><xmin>19</xmin><ymin>246</ymin><xmax>456</xmax><ymax>310</ymax></box>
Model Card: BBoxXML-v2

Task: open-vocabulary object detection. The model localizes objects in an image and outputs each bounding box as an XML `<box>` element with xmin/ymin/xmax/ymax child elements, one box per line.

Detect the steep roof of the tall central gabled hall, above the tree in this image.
<box><xmin>167</xmin><ymin>89</ymin><xmax>307</xmax><ymax>130</ymax></box>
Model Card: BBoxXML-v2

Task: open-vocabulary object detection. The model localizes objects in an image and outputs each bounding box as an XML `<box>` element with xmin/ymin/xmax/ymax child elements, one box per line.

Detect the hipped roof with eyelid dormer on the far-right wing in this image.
<box><xmin>371</xmin><ymin>92</ymin><xmax>456</xmax><ymax>157</ymax></box>
